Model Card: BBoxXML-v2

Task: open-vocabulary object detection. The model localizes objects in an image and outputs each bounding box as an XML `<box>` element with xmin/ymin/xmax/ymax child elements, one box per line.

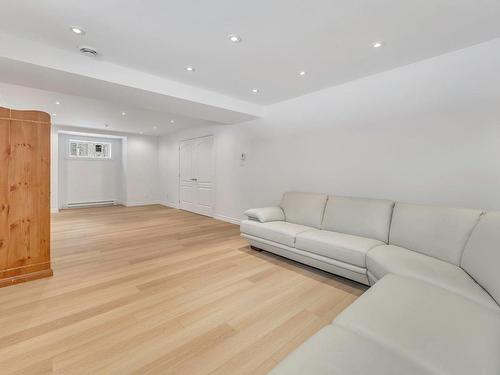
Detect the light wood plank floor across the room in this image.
<box><xmin>0</xmin><ymin>206</ymin><xmax>365</xmax><ymax>375</ymax></box>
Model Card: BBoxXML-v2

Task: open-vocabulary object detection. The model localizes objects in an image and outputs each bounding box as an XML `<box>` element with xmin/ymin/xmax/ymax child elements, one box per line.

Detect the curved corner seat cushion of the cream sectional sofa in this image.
<box><xmin>366</xmin><ymin>245</ymin><xmax>498</xmax><ymax>308</ymax></box>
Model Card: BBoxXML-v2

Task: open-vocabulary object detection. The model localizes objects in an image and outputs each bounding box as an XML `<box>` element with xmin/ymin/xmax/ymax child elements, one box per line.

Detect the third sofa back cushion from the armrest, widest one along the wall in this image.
<box><xmin>389</xmin><ymin>203</ymin><xmax>481</xmax><ymax>265</ymax></box>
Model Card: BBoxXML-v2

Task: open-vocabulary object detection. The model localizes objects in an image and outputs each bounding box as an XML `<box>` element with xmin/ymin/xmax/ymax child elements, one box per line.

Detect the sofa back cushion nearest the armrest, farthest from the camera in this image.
<box><xmin>280</xmin><ymin>191</ymin><xmax>328</xmax><ymax>229</ymax></box>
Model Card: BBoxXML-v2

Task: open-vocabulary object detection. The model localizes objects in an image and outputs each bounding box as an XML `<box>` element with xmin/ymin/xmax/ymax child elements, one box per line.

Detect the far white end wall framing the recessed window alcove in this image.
<box><xmin>51</xmin><ymin>126</ymin><xmax>159</xmax><ymax>212</ymax></box>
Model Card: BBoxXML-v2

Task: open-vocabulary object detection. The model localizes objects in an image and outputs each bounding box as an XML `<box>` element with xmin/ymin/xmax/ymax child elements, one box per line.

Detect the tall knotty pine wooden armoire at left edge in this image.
<box><xmin>0</xmin><ymin>107</ymin><xmax>52</xmax><ymax>287</ymax></box>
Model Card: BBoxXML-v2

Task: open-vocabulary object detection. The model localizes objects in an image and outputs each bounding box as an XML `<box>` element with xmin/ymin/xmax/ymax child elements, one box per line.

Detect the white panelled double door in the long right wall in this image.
<box><xmin>179</xmin><ymin>136</ymin><xmax>214</xmax><ymax>216</ymax></box>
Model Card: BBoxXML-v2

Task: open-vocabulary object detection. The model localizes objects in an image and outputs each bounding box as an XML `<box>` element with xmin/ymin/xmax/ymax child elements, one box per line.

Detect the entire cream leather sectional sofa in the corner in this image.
<box><xmin>241</xmin><ymin>192</ymin><xmax>500</xmax><ymax>375</ymax></box>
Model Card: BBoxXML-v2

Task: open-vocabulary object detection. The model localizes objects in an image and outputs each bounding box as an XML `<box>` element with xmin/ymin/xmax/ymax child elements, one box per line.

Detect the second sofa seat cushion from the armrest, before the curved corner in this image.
<box><xmin>295</xmin><ymin>230</ymin><xmax>384</xmax><ymax>268</ymax></box>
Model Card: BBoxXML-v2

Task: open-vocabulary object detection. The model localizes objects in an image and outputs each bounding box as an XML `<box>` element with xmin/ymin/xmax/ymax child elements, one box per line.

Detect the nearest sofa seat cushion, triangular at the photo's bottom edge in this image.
<box><xmin>269</xmin><ymin>325</ymin><xmax>433</xmax><ymax>375</ymax></box>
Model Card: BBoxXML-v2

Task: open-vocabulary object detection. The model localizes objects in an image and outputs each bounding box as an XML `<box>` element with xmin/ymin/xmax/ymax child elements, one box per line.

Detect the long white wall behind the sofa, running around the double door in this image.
<box><xmin>159</xmin><ymin>39</ymin><xmax>500</xmax><ymax>222</ymax></box>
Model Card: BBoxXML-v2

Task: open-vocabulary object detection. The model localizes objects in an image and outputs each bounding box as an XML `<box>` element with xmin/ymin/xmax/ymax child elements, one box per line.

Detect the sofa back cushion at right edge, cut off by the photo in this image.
<box><xmin>461</xmin><ymin>212</ymin><xmax>500</xmax><ymax>305</ymax></box>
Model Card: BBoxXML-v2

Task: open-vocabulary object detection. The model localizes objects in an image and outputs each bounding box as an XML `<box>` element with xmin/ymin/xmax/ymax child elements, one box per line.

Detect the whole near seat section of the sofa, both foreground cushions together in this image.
<box><xmin>270</xmin><ymin>275</ymin><xmax>500</xmax><ymax>375</ymax></box>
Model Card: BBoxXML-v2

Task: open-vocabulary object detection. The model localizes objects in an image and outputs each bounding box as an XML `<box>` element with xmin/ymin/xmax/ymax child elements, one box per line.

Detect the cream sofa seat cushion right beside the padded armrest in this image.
<box><xmin>241</xmin><ymin>220</ymin><xmax>312</xmax><ymax>247</ymax></box>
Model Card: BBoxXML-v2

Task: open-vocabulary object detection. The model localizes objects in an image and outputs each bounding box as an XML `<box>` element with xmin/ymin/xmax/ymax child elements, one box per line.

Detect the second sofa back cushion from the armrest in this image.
<box><xmin>322</xmin><ymin>195</ymin><xmax>394</xmax><ymax>243</ymax></box>
